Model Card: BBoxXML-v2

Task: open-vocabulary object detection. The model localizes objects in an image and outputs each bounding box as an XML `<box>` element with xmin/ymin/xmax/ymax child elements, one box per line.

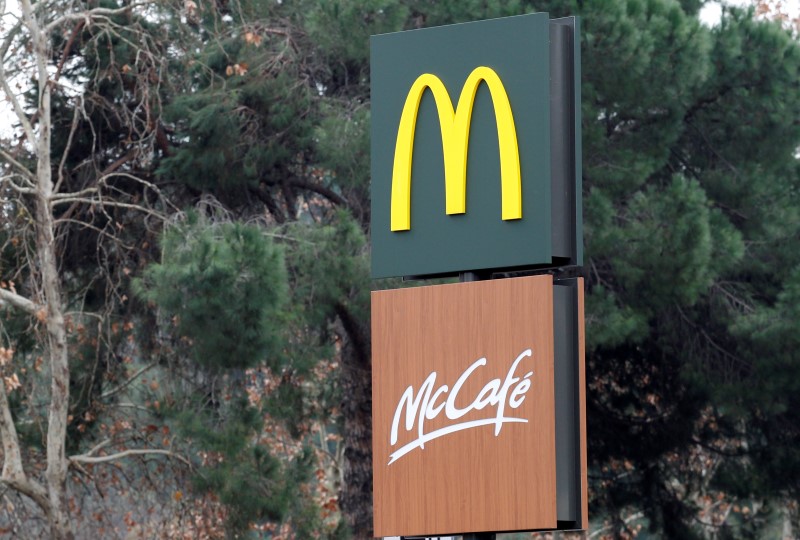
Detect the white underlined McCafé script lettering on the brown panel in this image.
<box><xmin>389</xmin><ymin>349</ymin><xmax>533</xmax><ymax>465</ymax></box>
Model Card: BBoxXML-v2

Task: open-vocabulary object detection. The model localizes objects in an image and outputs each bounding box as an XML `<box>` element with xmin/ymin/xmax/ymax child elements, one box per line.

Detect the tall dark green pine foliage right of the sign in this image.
<box><xmin>582</xmin><ymin>2</ymin><xmax>800</xmax><ymax>538</ymax></box>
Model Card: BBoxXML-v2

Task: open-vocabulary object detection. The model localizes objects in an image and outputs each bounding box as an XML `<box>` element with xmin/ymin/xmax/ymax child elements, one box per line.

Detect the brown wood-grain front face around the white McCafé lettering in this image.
<box><xmin>372</xmin><ymin>276</ymin><xmax>556</xmax><ymax>536</ymax></box>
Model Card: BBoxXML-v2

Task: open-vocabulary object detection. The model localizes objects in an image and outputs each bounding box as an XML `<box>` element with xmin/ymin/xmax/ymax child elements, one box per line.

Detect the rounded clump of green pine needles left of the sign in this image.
<box><xmin>134</xmin><ymin>214</ymin><xmax>287</xmax><ymax>369</ymax></box>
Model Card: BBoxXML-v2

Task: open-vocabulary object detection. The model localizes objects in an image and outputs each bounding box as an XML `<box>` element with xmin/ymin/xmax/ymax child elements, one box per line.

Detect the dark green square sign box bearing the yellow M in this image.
<box><xmin>371</xmin><ymin>13</ymin><xmax>582</xmax><ymax>277</ymax></box>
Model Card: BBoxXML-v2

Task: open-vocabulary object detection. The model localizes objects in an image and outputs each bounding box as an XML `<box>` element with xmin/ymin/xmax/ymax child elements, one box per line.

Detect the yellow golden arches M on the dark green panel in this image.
<box><xmin>391</xmin><ymin>66</ymin><xmax>522</xmax><ymax>231</ymax></box>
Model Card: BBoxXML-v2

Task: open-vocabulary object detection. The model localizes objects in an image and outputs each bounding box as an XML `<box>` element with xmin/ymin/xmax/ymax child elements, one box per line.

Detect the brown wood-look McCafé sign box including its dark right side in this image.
<box><xmin>372</xmin><ymin>275</ymin><xmax>588</xmax><ymax>536</ymax></box>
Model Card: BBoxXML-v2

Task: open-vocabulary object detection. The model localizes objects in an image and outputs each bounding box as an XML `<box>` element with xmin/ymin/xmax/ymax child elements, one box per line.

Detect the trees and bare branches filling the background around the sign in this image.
<box><xmin>0</xmin><ymin>0</ymin><xmax>800</xmax><ymax>539</ymax></box>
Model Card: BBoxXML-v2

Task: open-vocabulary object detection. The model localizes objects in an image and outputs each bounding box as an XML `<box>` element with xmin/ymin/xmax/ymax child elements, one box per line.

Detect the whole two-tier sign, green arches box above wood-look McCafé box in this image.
<box><xmin>371</xmin><ymin>13</ymin><xmax>588</xmax><ymax>538</ymax></box>
